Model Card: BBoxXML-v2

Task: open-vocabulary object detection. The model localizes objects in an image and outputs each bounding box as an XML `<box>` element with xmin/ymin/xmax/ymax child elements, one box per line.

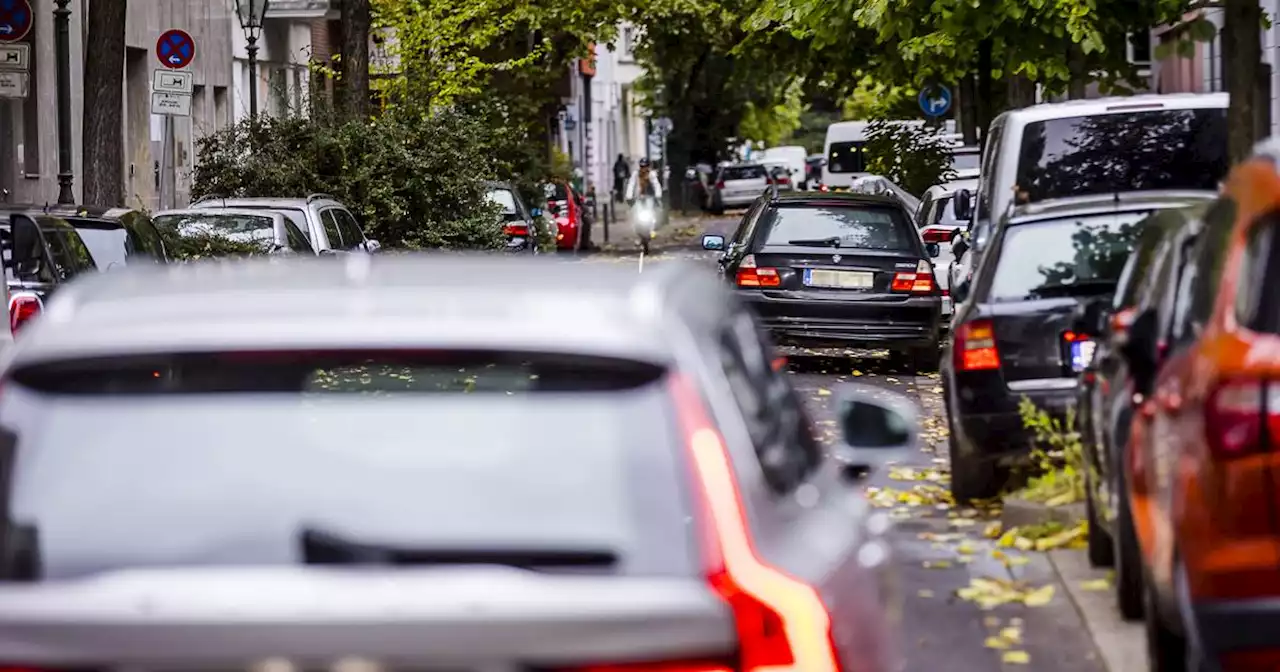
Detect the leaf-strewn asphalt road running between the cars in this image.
<box><xmin>588</xmin><ymin>218</ymin><xmax>1119</xmax><ymax>672</ymax></box>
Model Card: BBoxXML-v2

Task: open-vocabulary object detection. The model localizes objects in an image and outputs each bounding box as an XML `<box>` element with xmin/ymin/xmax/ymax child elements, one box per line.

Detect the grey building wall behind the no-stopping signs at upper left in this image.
<box><xmin>0</xmin><ymin>0</ymin><xmax>239</xmax><ymax>209</ymax></box>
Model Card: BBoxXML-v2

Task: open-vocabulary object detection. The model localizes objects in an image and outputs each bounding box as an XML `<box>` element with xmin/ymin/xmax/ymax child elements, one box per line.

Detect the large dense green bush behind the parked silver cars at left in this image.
<box><xmin>192</xmin><ymin>106</ymin><xmax>513</xmax><ymax>248</ymax></box>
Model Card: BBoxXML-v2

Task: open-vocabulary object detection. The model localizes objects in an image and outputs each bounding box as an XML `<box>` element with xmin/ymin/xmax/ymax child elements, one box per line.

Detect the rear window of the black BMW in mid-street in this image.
<box><xmin>764</xmin><ymin>205</ymin><xmax>918</xmax><ymax>251</ymax></box>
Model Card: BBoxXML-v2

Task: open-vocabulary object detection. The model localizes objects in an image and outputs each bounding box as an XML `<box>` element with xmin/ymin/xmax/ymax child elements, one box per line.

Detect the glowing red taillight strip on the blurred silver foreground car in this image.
<box><xmin>671</xmin><ymin>374</ymin><xmax>840</xmax><ymax>672</ymax></box>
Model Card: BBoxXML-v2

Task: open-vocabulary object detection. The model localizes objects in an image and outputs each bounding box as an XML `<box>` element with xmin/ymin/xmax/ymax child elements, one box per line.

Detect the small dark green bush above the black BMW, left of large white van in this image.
<box><xmin>863</xmin><ymin>119</ymin><xmax>955</xmax><ymax>197</ymax></box>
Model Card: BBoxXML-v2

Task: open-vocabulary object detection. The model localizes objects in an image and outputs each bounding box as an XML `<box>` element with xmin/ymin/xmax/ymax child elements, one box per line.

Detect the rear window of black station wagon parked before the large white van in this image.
<box><xmin>989</xmin><ymin>212</ymin><xmax>1147</xmax><ymax>301</ymax></box>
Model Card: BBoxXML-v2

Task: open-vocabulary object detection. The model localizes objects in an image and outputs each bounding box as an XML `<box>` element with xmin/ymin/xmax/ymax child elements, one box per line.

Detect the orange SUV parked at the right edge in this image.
<box><xmin>1125</xmin><ymin>142</ymin><xmax>1280</xmax><ymax>672</ymax></box>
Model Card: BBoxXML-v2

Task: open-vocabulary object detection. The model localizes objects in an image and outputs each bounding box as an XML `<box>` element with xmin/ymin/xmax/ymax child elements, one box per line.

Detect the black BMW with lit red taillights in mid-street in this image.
<box><xmin>703</xmin><ymin>192</ymin><xmax>942</xmax><ymax>370</ymax></box>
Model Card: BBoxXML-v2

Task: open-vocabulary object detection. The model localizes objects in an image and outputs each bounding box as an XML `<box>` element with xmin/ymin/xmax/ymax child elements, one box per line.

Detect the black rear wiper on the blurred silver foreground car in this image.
<box><xmin>301</xmin><ymin>529</ymin><xmax>618</xmax><ymax>570</ymax></box>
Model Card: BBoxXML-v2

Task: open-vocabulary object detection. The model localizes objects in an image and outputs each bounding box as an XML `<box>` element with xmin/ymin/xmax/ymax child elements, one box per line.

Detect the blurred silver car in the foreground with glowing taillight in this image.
<box><xmin>0</xmin><ymin>255</ymin><xmax>919</xmax><ymax>672</ymax></box>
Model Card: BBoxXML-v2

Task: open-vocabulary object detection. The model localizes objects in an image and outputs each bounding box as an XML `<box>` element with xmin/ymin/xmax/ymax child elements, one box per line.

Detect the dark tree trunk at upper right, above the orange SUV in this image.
<box><xmin>1222</xmin><ymin>0</ymin><xmax>1262</xmax><ymax>163</ymax></box>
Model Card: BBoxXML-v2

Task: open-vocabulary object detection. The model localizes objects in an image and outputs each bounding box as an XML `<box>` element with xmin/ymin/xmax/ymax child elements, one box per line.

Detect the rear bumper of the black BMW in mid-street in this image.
<box><xmin>742</xmin><ymin>291</ymin><xmax>942</xmax><ymax>349</ymax></box>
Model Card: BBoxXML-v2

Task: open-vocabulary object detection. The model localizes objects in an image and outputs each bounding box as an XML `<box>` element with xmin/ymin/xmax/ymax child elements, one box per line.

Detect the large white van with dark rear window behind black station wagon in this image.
<box><xmin>970</xmin><ymin>93</ymin><xmax>1230</xmax><ymax>252</ymax></box>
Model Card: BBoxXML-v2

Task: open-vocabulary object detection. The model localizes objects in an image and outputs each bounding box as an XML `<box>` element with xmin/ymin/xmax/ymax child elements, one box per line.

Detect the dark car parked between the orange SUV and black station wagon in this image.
<box><xmin>1074</xmin><ymin>205</ymin><xmax>1206</xmax><ymax>618</ymax></box>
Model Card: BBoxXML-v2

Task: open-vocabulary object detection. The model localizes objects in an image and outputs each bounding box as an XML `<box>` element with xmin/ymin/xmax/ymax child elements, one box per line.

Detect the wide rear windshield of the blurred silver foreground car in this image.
<box><xmin>4</xmin><ymin>352</ymin><xmax>696</xmax><ymax>579</ymax></box>
